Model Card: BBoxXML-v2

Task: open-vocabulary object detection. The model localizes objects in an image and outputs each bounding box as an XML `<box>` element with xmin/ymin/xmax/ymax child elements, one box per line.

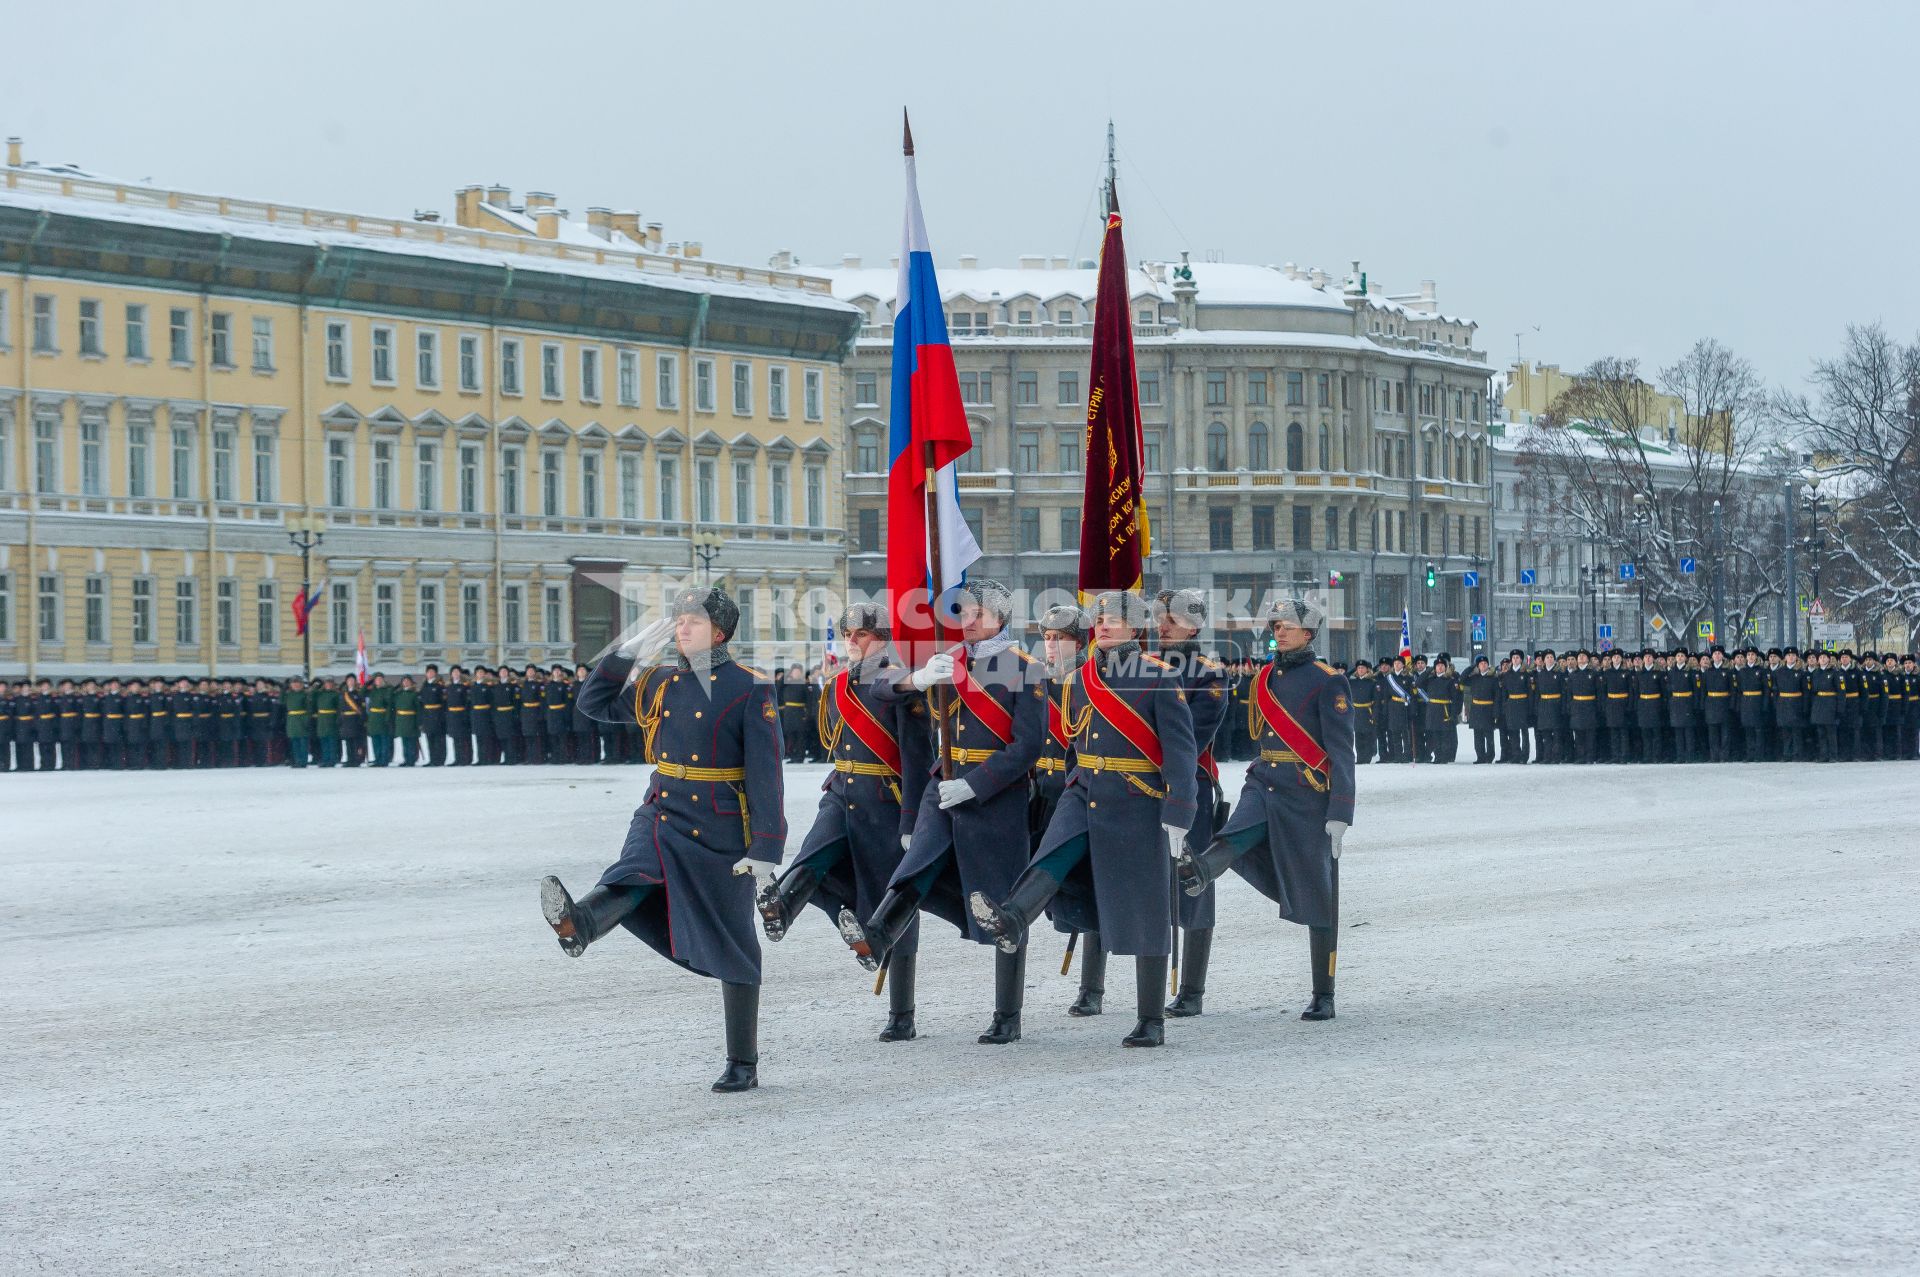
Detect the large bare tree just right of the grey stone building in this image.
<box><xmin>1519</xmin><ymin>338</ymin><xmax>1784</xmax><ymax>638</ymax></box>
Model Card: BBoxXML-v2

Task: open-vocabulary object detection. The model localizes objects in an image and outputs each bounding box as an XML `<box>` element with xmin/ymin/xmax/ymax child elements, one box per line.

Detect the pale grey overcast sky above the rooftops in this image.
<box><xmin>0</xmin><ymin>0</ymin><xmax>1920</xmax><ymax>382</ymax></box>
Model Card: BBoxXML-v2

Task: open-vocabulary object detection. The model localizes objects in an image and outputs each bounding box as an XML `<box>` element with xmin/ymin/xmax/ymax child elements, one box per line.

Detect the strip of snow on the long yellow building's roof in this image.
<box><xmin>0</xmin><ymin>169</ymin><xmax>856</xmax><ymax>313</ymax></box>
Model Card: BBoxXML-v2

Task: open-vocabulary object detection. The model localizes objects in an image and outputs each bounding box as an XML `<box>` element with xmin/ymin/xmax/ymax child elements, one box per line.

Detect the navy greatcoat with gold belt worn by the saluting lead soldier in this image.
<box><xmin>580</xmin><ymin>653</ymin><xmax>787</xmax><ymax>985</ymax></box>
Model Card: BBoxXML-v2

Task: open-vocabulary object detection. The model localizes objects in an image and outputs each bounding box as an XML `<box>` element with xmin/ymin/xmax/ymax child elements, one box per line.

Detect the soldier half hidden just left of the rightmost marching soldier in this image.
<box><xmin>1152</xmin><ymin>590</ymin><xmax>1228</xmax><ymax>1020</ymax></box>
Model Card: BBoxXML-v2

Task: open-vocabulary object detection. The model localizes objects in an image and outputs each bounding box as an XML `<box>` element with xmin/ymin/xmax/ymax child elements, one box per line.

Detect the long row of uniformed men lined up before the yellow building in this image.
<box><xmin>0</xmin><ymin>664</ymin><xmax>848</xmax><ymax>772</ymax></box>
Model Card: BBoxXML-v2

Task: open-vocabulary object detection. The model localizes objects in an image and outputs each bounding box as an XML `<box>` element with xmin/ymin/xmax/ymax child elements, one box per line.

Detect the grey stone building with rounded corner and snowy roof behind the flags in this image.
<box><xmin>824</xmin><ymin>257</ymin><xmax>1490</xmax><ymax>659</ymax></box>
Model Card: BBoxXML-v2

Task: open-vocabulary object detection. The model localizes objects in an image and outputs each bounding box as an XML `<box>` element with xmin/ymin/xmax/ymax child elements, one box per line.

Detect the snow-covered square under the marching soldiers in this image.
<box><xmin>0</xmin><ymin>764</ymin><xmax>1920</xmax><ymax>1277</ymax></box>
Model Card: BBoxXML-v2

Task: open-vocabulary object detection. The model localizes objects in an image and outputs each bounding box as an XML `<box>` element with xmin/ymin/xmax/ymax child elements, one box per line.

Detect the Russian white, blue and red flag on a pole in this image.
<box><xmin>887</xmin><ymin>114</ymin><xmax>979</xmax><ymax>653</ymax></box>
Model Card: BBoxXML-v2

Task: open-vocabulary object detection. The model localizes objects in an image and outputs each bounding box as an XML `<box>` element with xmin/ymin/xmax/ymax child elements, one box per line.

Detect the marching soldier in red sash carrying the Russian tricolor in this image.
<box><xmin>839</xmin><ymin>578</ymin><xmax>1046</xmax><ymax>1047</ymax></box>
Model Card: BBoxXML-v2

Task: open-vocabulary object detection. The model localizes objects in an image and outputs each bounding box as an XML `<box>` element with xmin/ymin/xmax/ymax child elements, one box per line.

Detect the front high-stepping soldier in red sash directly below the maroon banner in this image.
<box><xmin>968</xmin><ymin>590</ymin><xmax>1198</xmax><ymax>1047</ymax></box>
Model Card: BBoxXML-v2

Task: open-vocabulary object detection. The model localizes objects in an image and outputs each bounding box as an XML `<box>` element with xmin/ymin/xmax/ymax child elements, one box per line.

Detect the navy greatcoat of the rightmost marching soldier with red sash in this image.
<box><xmin>1223</xmin><ymin>661</ymin><xmax>1354</xmax><ymax>928</ymax></box>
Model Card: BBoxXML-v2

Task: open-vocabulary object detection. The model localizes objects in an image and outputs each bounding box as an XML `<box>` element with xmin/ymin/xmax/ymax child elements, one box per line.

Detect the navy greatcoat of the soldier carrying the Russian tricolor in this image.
<box><xmin>887</xmin><ymin>643</ymin><xmax>1046</xmax><ymax>945</ymax></box>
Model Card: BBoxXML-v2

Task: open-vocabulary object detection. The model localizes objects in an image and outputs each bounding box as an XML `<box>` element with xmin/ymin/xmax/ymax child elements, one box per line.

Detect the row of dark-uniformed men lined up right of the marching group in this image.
<box><xmin>1305</xmin><ymin>647</ymin><xmax>1920</xmax><ymax>762</ymax></box>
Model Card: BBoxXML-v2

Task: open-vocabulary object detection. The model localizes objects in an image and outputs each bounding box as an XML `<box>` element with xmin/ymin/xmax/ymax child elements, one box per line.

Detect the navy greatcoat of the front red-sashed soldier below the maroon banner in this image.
<box><xmin>1033</xmin><ymin>643</ymin><xmax>1219</xmax><ymax>958</ymax></box>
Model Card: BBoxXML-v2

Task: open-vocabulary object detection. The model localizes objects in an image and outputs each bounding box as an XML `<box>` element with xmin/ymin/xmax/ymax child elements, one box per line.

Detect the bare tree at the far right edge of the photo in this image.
<box><xmin>1774</xmin><ymin>325</ymin><xmax>1920</xmax><ymax>632</ymax></box>
